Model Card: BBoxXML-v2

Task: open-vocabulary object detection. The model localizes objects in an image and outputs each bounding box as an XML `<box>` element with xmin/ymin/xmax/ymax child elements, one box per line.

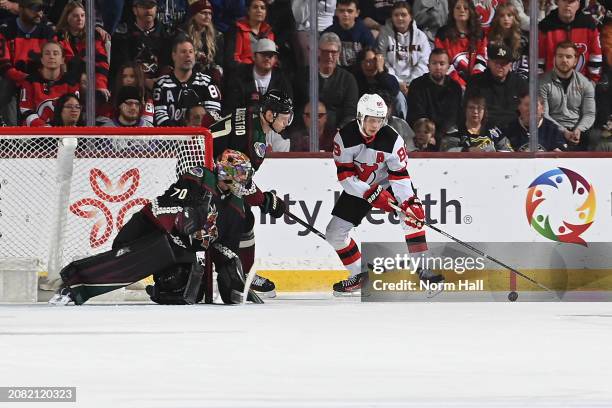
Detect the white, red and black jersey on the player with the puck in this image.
<box><xmin>333</xmin><ymin>120</ymin><xmax>414</xmax><ymax>203</ymax></box>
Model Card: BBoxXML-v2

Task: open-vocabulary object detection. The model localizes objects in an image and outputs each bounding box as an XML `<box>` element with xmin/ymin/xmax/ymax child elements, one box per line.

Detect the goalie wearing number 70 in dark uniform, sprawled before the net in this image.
<box><xmin>50</xmin><ymin>150</ymin><xmax>253</xmax><ymax>304</ymax></box>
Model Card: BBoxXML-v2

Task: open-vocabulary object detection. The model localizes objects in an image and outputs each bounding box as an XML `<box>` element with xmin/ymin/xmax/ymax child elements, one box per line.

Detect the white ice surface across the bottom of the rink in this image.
<box><xmin>0</xmin><ymin>294</ymin><xmax>612</xmax><ymax>408</ymax></box>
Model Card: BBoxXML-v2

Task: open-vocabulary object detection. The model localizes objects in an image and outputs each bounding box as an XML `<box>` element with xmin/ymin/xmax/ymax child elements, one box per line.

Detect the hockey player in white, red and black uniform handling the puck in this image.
<box><xmin>326</xmin><ymin>94</ymin><xmax>444</xmax><ymax>296</ymax></box>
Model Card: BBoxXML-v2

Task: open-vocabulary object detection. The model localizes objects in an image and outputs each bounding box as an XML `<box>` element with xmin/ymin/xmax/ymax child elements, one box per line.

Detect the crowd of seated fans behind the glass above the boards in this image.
<box><xmin>0</xmin><ymin>0</ymin><xmax>612</xmax><ymax>151</ymax></box>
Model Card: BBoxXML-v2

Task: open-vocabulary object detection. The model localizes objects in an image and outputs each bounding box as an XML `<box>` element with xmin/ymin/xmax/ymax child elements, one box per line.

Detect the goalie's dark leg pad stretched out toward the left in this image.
<box><xmin>60</xmin><ymin>231</ymin><xmax>176</xmax><ymax>305</ymax></box>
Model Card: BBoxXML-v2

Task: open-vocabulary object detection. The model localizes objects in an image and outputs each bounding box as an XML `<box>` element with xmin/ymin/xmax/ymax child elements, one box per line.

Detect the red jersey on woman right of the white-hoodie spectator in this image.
<box><xmin>435</xmin><ymin>26</ymin><xmax>487</xmax><ymax>89</ymax></box>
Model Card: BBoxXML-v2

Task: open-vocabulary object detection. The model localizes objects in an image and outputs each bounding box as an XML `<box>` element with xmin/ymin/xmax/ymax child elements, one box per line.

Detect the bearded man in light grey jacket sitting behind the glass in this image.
<box><xmin>540</xmin><ymin>40</ymin><xmax>595</xmax><ymax>150</ymax></box>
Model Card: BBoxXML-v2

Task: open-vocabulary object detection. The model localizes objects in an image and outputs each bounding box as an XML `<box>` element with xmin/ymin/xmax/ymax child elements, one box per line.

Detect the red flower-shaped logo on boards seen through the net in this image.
<box><xmin>70</xmin><ymin>168</ymin><xmax>149</xmax><ymax>248</ymax></box>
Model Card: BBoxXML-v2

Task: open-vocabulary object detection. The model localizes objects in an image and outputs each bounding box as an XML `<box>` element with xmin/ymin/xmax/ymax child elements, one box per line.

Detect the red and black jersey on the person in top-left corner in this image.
<box><xmin>0</xmin><ymin>19</ymin><xmax>55</xmax><ymax>85</ymax></box>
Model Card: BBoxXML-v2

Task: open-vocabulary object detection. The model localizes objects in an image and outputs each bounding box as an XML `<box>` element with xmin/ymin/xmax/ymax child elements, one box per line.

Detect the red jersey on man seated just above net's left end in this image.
<box><xmin>19</xmin><ymin>73</ymin><xmax>80</xmax><ymax>126</ymax></box>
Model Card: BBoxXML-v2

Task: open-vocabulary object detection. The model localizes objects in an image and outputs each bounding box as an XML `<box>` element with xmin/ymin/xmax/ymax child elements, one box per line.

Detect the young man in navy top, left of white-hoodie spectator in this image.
<box><xmin>324</xmin><ymin>0</ymin><xmax>376</xmax><ymax>67</ymax></box>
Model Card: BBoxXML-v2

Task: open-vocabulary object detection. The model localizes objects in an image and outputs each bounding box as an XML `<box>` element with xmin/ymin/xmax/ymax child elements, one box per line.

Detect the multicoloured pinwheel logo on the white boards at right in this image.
<box><xmin>525</xmin><ymin>167</ymin><xmax>596</xmax><ymax>246</ymax></box>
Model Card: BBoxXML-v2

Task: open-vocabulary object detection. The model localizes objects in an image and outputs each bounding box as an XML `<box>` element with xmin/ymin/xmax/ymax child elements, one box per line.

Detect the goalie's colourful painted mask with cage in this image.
<box><xmin>215</xmin><ymin>149</ymin><xmax>254</xmax><ymax>197</ymax></box>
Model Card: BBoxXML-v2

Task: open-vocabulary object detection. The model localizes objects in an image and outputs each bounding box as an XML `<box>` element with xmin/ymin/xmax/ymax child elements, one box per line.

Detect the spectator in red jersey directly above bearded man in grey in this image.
<box><xmin>538</xmin><ymin>0</ymin><xmax>601</xmax><ymax>82</ymax></box>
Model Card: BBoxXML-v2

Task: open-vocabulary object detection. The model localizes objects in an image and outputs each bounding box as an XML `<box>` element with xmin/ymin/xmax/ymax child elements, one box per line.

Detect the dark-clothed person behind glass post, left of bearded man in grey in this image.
<box><xmin>504</xmin><ymin>91</ymin><xmax>567</xmax><ymax>152</ymax></box>
